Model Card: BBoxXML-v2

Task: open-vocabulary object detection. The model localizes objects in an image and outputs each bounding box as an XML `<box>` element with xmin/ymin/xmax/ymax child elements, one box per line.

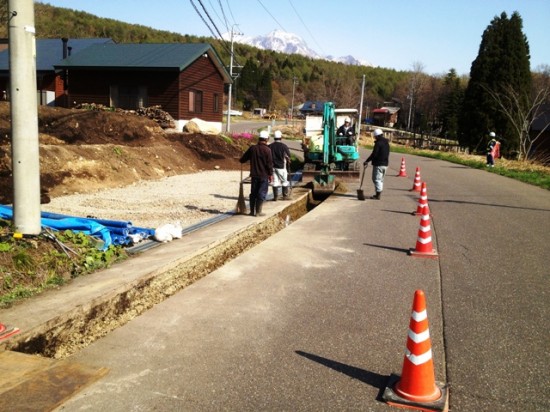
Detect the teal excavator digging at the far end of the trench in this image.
<box><xmin>302</xmin><ymin>102</ymin><xmax>361</xmax><ymax>195</ymax></box>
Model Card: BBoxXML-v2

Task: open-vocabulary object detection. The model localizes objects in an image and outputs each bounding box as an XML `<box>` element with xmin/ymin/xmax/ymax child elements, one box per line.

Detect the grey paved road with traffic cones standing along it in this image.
<box><xmin>59</xmin><ymin>154</ymin><xmax>550</xmax><ymax>411</ymax></box>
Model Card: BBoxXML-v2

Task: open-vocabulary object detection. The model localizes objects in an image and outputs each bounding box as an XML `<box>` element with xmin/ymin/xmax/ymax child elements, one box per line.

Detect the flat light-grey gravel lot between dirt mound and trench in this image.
<box><xmin>46</xmin><ymin>171</ymin><xmax>245</xmax><ymax>228</ymax></box>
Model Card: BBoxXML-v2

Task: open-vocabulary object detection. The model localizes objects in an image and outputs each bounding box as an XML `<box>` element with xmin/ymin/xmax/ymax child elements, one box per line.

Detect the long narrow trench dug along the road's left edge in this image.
<box><xmin>7</xmin><ymin>186</ymin><xmax>327</xmax><ymax>359</ymax></box>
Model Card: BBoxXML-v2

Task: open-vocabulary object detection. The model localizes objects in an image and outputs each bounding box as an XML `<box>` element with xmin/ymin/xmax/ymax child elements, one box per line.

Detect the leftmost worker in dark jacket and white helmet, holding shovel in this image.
<box><xmin>240</xmin><ymin>130</ymin><xmax>273</xmax><ymax>216</ymax></box>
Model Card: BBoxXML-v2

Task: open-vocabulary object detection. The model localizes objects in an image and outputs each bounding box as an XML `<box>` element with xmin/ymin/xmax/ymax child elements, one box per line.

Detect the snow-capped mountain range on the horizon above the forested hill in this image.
<box><xmin>223</xmin><ymin>30</ymin><xmax>371</xmax><ymax>66</ymax></box>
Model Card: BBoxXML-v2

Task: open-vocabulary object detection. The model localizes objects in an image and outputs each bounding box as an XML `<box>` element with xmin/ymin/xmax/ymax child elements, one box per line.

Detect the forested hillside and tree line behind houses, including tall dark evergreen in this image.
<box><xmin>0</xmin><ymin>2</ymin><xmax>550</xmax><ymax>159</ymax></box>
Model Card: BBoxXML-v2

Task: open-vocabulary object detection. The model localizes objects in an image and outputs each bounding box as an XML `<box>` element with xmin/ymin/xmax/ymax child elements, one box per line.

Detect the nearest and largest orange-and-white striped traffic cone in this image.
<box><xmin>382</xmin><ymin>290</ymin><xmax>448</xmax><ymax>411</ymax></box>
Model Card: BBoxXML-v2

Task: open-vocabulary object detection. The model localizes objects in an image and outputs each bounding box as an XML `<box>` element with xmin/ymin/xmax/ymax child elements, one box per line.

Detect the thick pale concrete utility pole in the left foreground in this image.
<box><xmin>8</xmin><ymin>0</ymin><xmax>42</xmax><ymax>235</ymax></box>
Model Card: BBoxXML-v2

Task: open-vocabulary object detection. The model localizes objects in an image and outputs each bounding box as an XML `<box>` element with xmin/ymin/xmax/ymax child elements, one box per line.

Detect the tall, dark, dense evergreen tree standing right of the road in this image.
<box><xmin>459</xmin><ymin>12</ymin><xmax>531</xmax><ymax>152</ymax></box>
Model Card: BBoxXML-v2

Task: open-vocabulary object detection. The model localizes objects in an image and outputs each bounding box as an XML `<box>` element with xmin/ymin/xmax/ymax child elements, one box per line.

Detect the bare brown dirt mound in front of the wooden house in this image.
<box><xmin>0</xmin><ymin>102</ymin><xmax>245</xmax><ymax>204</ymax></box>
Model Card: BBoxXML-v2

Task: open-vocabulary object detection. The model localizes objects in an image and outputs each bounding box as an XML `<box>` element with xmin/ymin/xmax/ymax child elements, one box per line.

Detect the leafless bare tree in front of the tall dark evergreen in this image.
<box><xmin>484</xmin><ymin>85</ymin><xmax>550</xmax><ymax>160</ymax></box>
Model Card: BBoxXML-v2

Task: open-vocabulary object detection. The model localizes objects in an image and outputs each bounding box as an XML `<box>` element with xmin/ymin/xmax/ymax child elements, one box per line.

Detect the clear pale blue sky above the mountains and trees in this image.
<box><xmin>36</xmin><ymin>0</ymin><xmax>550</xmax><ymax>74</ymax></box>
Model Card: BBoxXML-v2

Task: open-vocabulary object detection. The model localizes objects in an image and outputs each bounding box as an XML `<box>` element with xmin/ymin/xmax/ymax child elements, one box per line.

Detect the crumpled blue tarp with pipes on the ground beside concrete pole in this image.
<box><xmin>0</xmin><ymin>205</ymin><xmax>155</xmax><ymax>250</ymax></box>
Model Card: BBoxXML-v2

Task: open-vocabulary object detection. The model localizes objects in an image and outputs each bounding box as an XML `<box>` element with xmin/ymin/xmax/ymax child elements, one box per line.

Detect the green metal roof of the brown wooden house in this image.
<box><xmin>55</xmin><ymin>43</ymin><xmax>230</xmax><ymax>82</ymax></box>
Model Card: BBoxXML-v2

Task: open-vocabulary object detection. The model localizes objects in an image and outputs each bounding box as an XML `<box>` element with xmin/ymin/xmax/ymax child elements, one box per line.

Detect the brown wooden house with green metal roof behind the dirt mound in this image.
<box><xmin>54</xmin><ymin>43</ymin><xmax>235</xmax><ymax>130</ymax></box>
